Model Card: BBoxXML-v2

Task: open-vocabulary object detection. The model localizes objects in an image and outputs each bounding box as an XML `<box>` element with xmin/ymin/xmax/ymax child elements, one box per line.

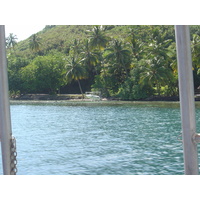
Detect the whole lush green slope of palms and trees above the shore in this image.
<box><xmin>7</xmin><ymin>25</ymin><xmax>200</xmax><ymax>100</ymax></box>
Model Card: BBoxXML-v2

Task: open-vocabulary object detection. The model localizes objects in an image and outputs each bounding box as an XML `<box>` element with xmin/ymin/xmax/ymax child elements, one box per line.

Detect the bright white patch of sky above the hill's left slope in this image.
<box><xmin>5</xmin><ymin>24</ymin><xmax>46</xmax><ymax>42</ymax></box>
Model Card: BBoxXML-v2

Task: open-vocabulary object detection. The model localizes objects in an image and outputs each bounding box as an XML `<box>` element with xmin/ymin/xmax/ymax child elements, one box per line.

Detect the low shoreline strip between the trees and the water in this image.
<box><xmin>10</xmin><ymin>94</ymin><xmax>179</xmax><ymax>107</ymax></box>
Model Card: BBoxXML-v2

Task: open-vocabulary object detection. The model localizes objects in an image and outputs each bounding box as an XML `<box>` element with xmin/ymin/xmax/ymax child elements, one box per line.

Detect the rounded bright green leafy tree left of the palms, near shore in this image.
<box><xmin>19</xmin><ymin>53</ymin><xmax>66</xmax><ymax>94</ymax></box>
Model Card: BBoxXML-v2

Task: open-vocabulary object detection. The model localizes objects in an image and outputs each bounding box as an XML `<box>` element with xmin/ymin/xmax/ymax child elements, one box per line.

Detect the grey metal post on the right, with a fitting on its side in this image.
<box><xmin>175</xmin><ymin>25</ymin><xmax>199</xmax><ymax>175</ymax></box>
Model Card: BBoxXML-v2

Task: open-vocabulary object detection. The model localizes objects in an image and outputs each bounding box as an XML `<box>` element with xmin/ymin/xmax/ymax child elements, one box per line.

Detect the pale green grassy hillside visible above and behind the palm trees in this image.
<box><xmin>10</xmin><ymin>25</ymin><xmax>200</xmax><ymax>58</ymax></box>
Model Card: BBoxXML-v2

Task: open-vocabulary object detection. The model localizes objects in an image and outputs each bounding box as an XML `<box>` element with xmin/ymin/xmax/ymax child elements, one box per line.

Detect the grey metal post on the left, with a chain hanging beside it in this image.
<box><xmin>0</xmin><ymin>25</ymin><xmax>12</xmax><ymax>175</ymax></box>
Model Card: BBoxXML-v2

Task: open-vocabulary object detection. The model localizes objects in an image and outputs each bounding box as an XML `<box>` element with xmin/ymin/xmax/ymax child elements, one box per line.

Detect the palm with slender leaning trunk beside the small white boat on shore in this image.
<box><xmin>66</xmin><ymin>56</ymin><xmax>88</xmax><ymax>98</ymax></box>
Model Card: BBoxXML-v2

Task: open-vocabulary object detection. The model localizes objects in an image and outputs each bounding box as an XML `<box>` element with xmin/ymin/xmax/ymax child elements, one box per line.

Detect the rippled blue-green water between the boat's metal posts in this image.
<box><xmin>0</xmin><ymin>102</ymin><xmax>200</xmax><ymax>175</ymax></box>
